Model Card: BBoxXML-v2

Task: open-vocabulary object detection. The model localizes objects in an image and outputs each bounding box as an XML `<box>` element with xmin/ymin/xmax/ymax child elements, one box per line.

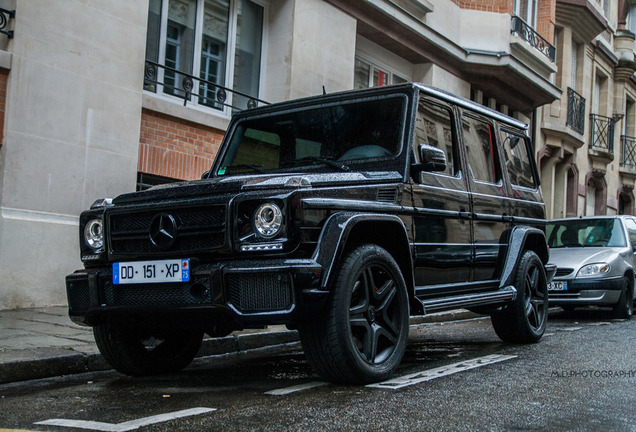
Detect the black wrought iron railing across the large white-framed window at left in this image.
<box><xmin>144</xmin><ymin>60</ymin><xmax>268</xmax><ymax>110</ymax></box>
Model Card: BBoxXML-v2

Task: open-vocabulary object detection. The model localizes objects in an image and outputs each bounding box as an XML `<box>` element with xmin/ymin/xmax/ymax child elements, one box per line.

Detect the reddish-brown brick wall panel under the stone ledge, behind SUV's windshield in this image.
<box><xmin>138</xmin><ymin>109</ymin><xmax>224</xmax><ymax>180</ymax></box>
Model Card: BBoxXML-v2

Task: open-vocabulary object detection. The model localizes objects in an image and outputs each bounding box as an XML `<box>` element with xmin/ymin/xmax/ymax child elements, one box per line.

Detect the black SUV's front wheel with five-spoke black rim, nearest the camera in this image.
<box><xmin>298</xmin><ymin>245</ymin><xmax>409</xmax><ymax>384</ymax></box>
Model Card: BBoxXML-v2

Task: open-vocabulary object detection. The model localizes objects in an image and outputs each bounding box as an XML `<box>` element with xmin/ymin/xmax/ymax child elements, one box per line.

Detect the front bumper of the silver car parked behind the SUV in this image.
<box><xmin>548</xmin><ymin>276</ymin><xmax>623</xmax><ymax>306</ymax></box>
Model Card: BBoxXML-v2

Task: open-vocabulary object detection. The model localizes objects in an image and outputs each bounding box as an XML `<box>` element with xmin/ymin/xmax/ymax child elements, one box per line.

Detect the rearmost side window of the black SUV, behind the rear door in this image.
<box><xmin>500</xmin><ymin>129</ymin><xmax>537</xmax><ymax>189</ymax></box>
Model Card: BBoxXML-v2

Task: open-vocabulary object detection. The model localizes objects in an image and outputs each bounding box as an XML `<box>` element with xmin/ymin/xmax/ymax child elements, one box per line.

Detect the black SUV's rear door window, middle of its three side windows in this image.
<box><xmin>462</xmin><ymin>115</ymin><xmax>500</xmax><ymax>183</ymax></box>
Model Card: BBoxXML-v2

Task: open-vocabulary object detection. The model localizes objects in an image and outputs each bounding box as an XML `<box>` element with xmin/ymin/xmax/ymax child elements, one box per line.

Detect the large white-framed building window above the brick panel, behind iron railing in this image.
<box><xmin>144</xmin><ymin>0</ymin><xmax>264</xmax><ymax>110</ymax></box>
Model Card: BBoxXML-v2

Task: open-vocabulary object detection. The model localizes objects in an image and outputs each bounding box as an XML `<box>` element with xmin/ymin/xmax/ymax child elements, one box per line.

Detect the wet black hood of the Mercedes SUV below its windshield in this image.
<box><xmin>113</xmin><ymin>171</ymin><xmax>402</xmax><ymax>205</ymax></box>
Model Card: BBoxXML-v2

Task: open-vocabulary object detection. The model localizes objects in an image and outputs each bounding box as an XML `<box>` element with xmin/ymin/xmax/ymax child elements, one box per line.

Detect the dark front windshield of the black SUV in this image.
<box><xmin>216</xmin><ymin>96</ymin><xmax>406</xmax><ymax>176</ymax></box>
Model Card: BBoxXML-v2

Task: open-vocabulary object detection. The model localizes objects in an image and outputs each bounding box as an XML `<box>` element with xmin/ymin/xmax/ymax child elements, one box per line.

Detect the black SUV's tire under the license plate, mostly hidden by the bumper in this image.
<box><xmin>93</xmin><ymin>322</ymin><xmax>203</xmax><ymax>376</ymax></box>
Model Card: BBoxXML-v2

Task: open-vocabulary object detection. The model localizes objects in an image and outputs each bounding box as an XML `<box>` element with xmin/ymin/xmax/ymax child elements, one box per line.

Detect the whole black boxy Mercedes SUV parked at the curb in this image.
<box><xmin>66</xmin><ymin>84</ymin><xmax>551</xmax><ymax>383</ymax></box>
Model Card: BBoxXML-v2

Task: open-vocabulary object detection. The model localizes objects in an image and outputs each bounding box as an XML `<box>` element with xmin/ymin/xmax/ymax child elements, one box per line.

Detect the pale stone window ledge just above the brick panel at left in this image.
<box><xmin>142</xmin><ymin>92</ymin><xmax>230</xmax><ymax>131</ymax></box>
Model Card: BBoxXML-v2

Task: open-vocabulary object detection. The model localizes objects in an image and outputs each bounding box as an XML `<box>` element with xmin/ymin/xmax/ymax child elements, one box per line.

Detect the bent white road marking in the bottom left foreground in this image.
<box><xmin>35</xmin><ymin>408</ymin><xmax>216</xmax><ymax>432</ymax></box>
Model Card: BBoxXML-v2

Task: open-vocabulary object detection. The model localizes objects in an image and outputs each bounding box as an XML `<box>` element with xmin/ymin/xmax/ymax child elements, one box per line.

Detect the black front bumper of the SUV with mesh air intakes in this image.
<box><xmin>66</xmin><ymin>260</ymin><xmax>328</xmax><ymax>328</ymax></box>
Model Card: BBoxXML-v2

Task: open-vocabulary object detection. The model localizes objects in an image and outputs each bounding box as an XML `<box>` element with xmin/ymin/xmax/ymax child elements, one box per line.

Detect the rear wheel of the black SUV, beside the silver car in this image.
<box><xmin>491</xmin><ymin>250</ymin><xmax>548</xmax><ymax>343</ymax></box>
